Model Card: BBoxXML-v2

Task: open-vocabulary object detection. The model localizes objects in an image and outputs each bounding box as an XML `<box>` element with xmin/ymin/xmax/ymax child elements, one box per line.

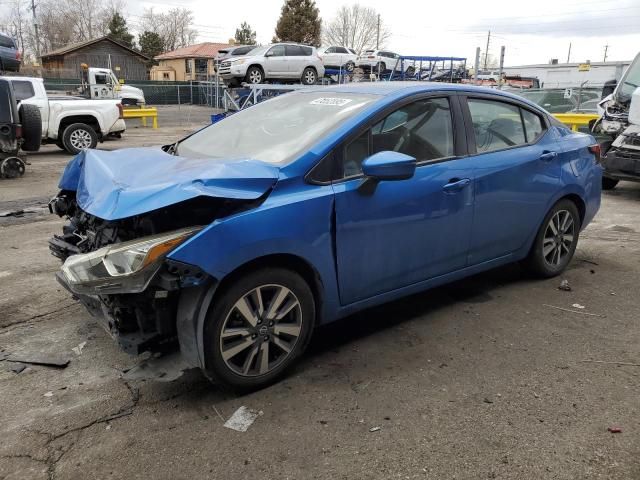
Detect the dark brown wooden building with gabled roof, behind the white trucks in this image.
<box><xmin>42</xmin><ymin>37</ymin><xmax>150</xmax><ymax>81</ymax></box>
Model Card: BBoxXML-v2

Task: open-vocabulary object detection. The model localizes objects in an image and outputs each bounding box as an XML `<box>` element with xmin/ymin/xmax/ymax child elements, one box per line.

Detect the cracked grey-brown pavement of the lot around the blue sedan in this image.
<box><xmin>0</xmin><ymin>107</ymin><xmax>640</xmax><ymax>480</ymax></box>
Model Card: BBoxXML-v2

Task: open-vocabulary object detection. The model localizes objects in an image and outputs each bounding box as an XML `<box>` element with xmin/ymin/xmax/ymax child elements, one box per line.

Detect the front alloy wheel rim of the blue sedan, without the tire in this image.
<box><xmin>220</xmin><ymin>284</ymin><xmax>303</xmax><ymax>377</ymax></box>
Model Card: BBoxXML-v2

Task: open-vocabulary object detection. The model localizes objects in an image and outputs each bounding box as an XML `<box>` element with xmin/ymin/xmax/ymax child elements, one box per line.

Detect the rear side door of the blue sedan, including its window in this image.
<box><xmin>463</xmin><ymin>96</ymin><xmax>560</xmax><ymax>265</ymax></box>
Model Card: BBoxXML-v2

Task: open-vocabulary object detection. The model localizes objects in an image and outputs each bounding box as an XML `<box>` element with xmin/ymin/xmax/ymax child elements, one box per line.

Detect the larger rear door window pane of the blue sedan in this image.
<box><xmin>468</xmin><ymin>99</ymin><xmax>526</xmax><ymax>153</ymax></box>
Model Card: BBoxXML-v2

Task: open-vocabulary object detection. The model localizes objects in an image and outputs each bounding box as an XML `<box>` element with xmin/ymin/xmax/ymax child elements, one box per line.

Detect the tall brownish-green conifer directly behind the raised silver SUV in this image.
<box><xmin>274</xmin><ymin>0</ymin><xmax>322</xmax><ymax>46</ymax></box>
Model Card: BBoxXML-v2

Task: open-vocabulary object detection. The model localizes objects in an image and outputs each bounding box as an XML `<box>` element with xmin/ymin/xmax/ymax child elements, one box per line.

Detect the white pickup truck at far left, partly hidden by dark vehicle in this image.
<box><xmin>0</xmin><ymin>77</ymin><xmax>126</xmax><ymax>154</ymax></box>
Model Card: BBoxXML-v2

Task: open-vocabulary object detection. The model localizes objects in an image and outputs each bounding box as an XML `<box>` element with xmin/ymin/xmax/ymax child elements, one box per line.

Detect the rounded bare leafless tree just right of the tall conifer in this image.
<box><xmin>322</xmin><ymin>3</ymin><xmax>391</xmax><ymax>54</ymax></box>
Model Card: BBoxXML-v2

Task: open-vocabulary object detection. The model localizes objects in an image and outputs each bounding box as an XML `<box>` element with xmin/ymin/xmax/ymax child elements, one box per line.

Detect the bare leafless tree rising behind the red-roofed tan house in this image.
<box><xmin>141</xmin><ymin>8</ymin><xmax>198</xmax><ymax>51</ymax></box>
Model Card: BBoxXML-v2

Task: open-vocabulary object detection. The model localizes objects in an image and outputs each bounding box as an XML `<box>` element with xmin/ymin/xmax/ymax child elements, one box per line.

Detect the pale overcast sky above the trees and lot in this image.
<box><xmin>128</xmin><ymin>0</ymin><xmax>640</xmax><ymax>66</ymax></box>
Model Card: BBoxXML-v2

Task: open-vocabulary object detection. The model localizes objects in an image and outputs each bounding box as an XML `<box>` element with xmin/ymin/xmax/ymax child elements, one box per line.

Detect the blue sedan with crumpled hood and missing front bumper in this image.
<box><xmin>49</xmin><ymin>82</ymin><xmax>602</xmax><ymax>390</ymax></box>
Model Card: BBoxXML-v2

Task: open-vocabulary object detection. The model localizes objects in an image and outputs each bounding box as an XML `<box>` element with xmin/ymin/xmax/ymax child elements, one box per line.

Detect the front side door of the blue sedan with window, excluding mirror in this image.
<box><xmin>334</xmin><ymin>97</ymin><xmax>473</xmax><ymax>305</ymax></box>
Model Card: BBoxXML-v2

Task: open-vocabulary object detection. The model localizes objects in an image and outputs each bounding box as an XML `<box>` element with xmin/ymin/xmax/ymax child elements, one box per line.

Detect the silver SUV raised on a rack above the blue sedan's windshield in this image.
<box><xmin>218</xmin><ymin>43</ymin><xmax>324</xmax><ymax>86</ymax></box>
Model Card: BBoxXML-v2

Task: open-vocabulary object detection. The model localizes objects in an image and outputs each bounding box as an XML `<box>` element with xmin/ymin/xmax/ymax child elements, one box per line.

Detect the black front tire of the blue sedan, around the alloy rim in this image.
<box><xmin>204</xmin><ymin>268</ymin><xmax>315</xmax><ymax>391</ymax></box>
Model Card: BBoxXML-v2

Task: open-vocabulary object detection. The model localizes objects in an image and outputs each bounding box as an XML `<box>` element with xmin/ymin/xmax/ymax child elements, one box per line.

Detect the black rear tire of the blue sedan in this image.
<box><xmin>524</xmin><ymin>199</ymin><xmax>580</xmax><ymax>278</ymax></box>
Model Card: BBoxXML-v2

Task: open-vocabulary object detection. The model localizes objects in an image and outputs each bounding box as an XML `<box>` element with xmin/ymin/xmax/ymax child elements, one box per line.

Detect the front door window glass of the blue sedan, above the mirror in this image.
<box><xmin>371</xmin><ymin>98</ymin><xmax>454</xmax><ymax>162</ymax></box>
